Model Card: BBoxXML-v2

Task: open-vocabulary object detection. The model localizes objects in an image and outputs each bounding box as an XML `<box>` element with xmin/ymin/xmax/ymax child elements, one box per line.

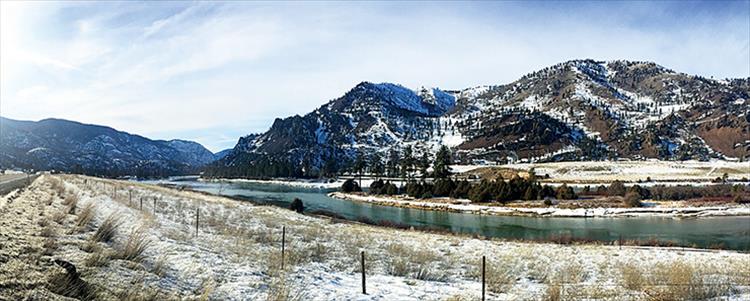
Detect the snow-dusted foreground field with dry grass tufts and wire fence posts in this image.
<box><xmin>0</xmin><ymin>175</ymin><xmax>750</xmax><ymax>300</ymax></box>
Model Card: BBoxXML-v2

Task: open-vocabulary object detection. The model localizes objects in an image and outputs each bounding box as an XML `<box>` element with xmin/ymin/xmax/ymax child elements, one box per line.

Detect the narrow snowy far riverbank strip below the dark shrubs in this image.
<box><xmin>328</xmin><ymin>192</ymin><xmax>750</xmax><ymax>218</ymax></box>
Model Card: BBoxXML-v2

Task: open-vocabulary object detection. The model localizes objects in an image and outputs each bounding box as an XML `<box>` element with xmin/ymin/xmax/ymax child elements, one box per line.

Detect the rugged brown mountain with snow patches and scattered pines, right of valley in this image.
<box><xmin>208</xmin><ymin>60</ymin><xmax>750</xmax><ymax>176</ymax></box>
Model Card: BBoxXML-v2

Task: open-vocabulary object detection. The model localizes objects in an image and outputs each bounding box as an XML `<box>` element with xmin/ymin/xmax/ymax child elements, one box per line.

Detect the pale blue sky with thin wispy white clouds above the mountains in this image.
<box><xmin>0</xmin><ymin>1</ymin><xmax>750</xmax><ymax>151</ymax></box>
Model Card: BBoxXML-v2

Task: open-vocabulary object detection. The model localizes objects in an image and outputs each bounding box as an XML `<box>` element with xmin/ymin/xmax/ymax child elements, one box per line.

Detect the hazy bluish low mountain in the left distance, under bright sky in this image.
<box><xmin>0</xmin><ymin>117</ymin><xmax>218</xmax><ymax>177</ymax></box>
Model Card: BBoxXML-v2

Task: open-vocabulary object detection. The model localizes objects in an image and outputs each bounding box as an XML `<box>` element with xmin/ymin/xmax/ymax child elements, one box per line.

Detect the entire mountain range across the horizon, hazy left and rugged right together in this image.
<box><xmin>0</xmin><ymin>60</ymin><xmax>750</xmax><ymax>177</ymax></box>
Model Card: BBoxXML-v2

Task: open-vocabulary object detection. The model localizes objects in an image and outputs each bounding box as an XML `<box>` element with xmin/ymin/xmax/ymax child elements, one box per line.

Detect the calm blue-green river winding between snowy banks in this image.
<box><xmin>154</xmin><ymin>179</ymin><xmax>750</xmax><ymax>251</ymax></box>
